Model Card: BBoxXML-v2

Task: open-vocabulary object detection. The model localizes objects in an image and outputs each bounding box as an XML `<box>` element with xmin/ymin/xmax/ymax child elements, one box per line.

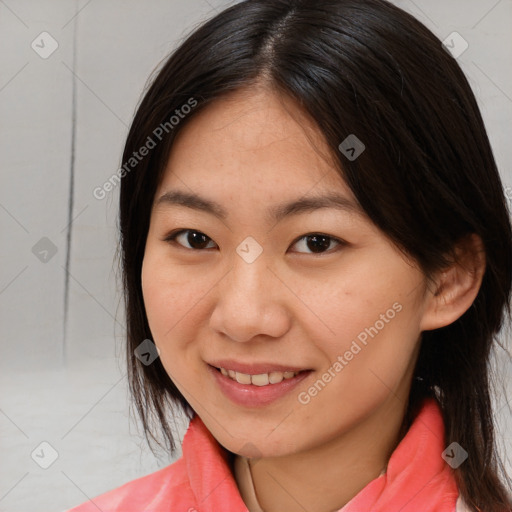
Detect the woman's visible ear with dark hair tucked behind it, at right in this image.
<box><xmin>420</xmin><ymin>233</ymin><xmax>486</xmax><ymax>331</ymax></box>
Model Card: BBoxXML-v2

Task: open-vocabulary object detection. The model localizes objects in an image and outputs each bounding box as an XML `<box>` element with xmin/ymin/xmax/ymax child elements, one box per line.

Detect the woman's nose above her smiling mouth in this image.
<box><xmin>210</xmin><ymin>255</ymin><xmax>291</xmax><ymax>342</ymax></box>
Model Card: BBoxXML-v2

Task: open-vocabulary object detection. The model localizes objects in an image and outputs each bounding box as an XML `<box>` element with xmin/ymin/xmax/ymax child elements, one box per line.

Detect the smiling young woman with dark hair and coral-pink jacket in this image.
<box><xmin>66</xmin><ymin>0</ymin><xmax>512</xmax><ymax>512</ymax></box>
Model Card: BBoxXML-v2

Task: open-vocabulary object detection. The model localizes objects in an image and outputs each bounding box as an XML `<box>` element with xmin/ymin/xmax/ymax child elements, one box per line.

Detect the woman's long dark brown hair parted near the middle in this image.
<box><xmin>119</xmin><ymin>0</ymin><xmax>512</xmax><ymax>512</ymax></box>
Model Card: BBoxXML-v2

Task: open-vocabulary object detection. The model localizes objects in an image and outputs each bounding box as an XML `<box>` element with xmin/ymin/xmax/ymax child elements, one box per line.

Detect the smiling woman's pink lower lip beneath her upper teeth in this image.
<box><xmin>208</xmin><ymin>365</ymin><xmax>312</xmax><ymax>407</ymax></box>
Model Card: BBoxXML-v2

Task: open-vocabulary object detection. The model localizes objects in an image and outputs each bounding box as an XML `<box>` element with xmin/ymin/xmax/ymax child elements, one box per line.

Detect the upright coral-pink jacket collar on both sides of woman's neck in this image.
<box><xmin>182</xmin><ymin>397</ymin><xmax>458</xmax><ymax>512</ymax></box>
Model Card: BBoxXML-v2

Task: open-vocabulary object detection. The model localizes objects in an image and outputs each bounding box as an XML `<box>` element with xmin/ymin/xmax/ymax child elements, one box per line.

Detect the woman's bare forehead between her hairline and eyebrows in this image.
<box><xmin>159</xmin><ymin>87</ymin><xmax>353</xmax><ymax>197</ymax></box>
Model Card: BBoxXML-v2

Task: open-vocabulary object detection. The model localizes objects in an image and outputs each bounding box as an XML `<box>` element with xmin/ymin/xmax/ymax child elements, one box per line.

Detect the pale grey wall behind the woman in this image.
<box><xmin>0</xmin><ymin>0</ymin><xmax>512</xmax><ymax>512</ymax></box>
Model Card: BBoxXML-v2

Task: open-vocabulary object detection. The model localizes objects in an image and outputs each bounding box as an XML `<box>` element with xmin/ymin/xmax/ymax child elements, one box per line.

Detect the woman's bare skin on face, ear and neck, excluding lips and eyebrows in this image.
<box><xmin>141</xmin><ymin>82</ymin><xmax>485</xmax><ymax>512</ymax></box>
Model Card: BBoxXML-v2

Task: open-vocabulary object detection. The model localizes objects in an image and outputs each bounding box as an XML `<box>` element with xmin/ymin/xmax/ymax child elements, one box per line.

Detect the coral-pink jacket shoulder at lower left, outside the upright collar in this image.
<box><xmin>62</xmin><ymin>457</ymin><xmax>194</xmax><ymax>512</ymax></box>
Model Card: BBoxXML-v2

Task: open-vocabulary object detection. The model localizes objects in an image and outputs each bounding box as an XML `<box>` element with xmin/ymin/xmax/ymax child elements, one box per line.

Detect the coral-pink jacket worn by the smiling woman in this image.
<box><xmin>68</xmin><ymin>398</ymin><xmax>468</xmax><ymax>512</ymax></box>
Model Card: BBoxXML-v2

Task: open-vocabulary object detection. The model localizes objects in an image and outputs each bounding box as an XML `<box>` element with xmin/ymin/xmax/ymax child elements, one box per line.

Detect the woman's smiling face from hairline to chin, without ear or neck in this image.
<box><xmin>141</xmin><ymin>88</ymin><xmax>427</xmax><ymax>456</ymax></box>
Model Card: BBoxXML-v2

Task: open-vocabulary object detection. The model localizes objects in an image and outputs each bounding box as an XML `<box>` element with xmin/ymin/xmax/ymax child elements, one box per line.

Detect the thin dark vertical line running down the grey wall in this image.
<box><xmin>62</xmin><ymin>0</ymin><xmax>79</xmax><ymax>365</ymax></box>
